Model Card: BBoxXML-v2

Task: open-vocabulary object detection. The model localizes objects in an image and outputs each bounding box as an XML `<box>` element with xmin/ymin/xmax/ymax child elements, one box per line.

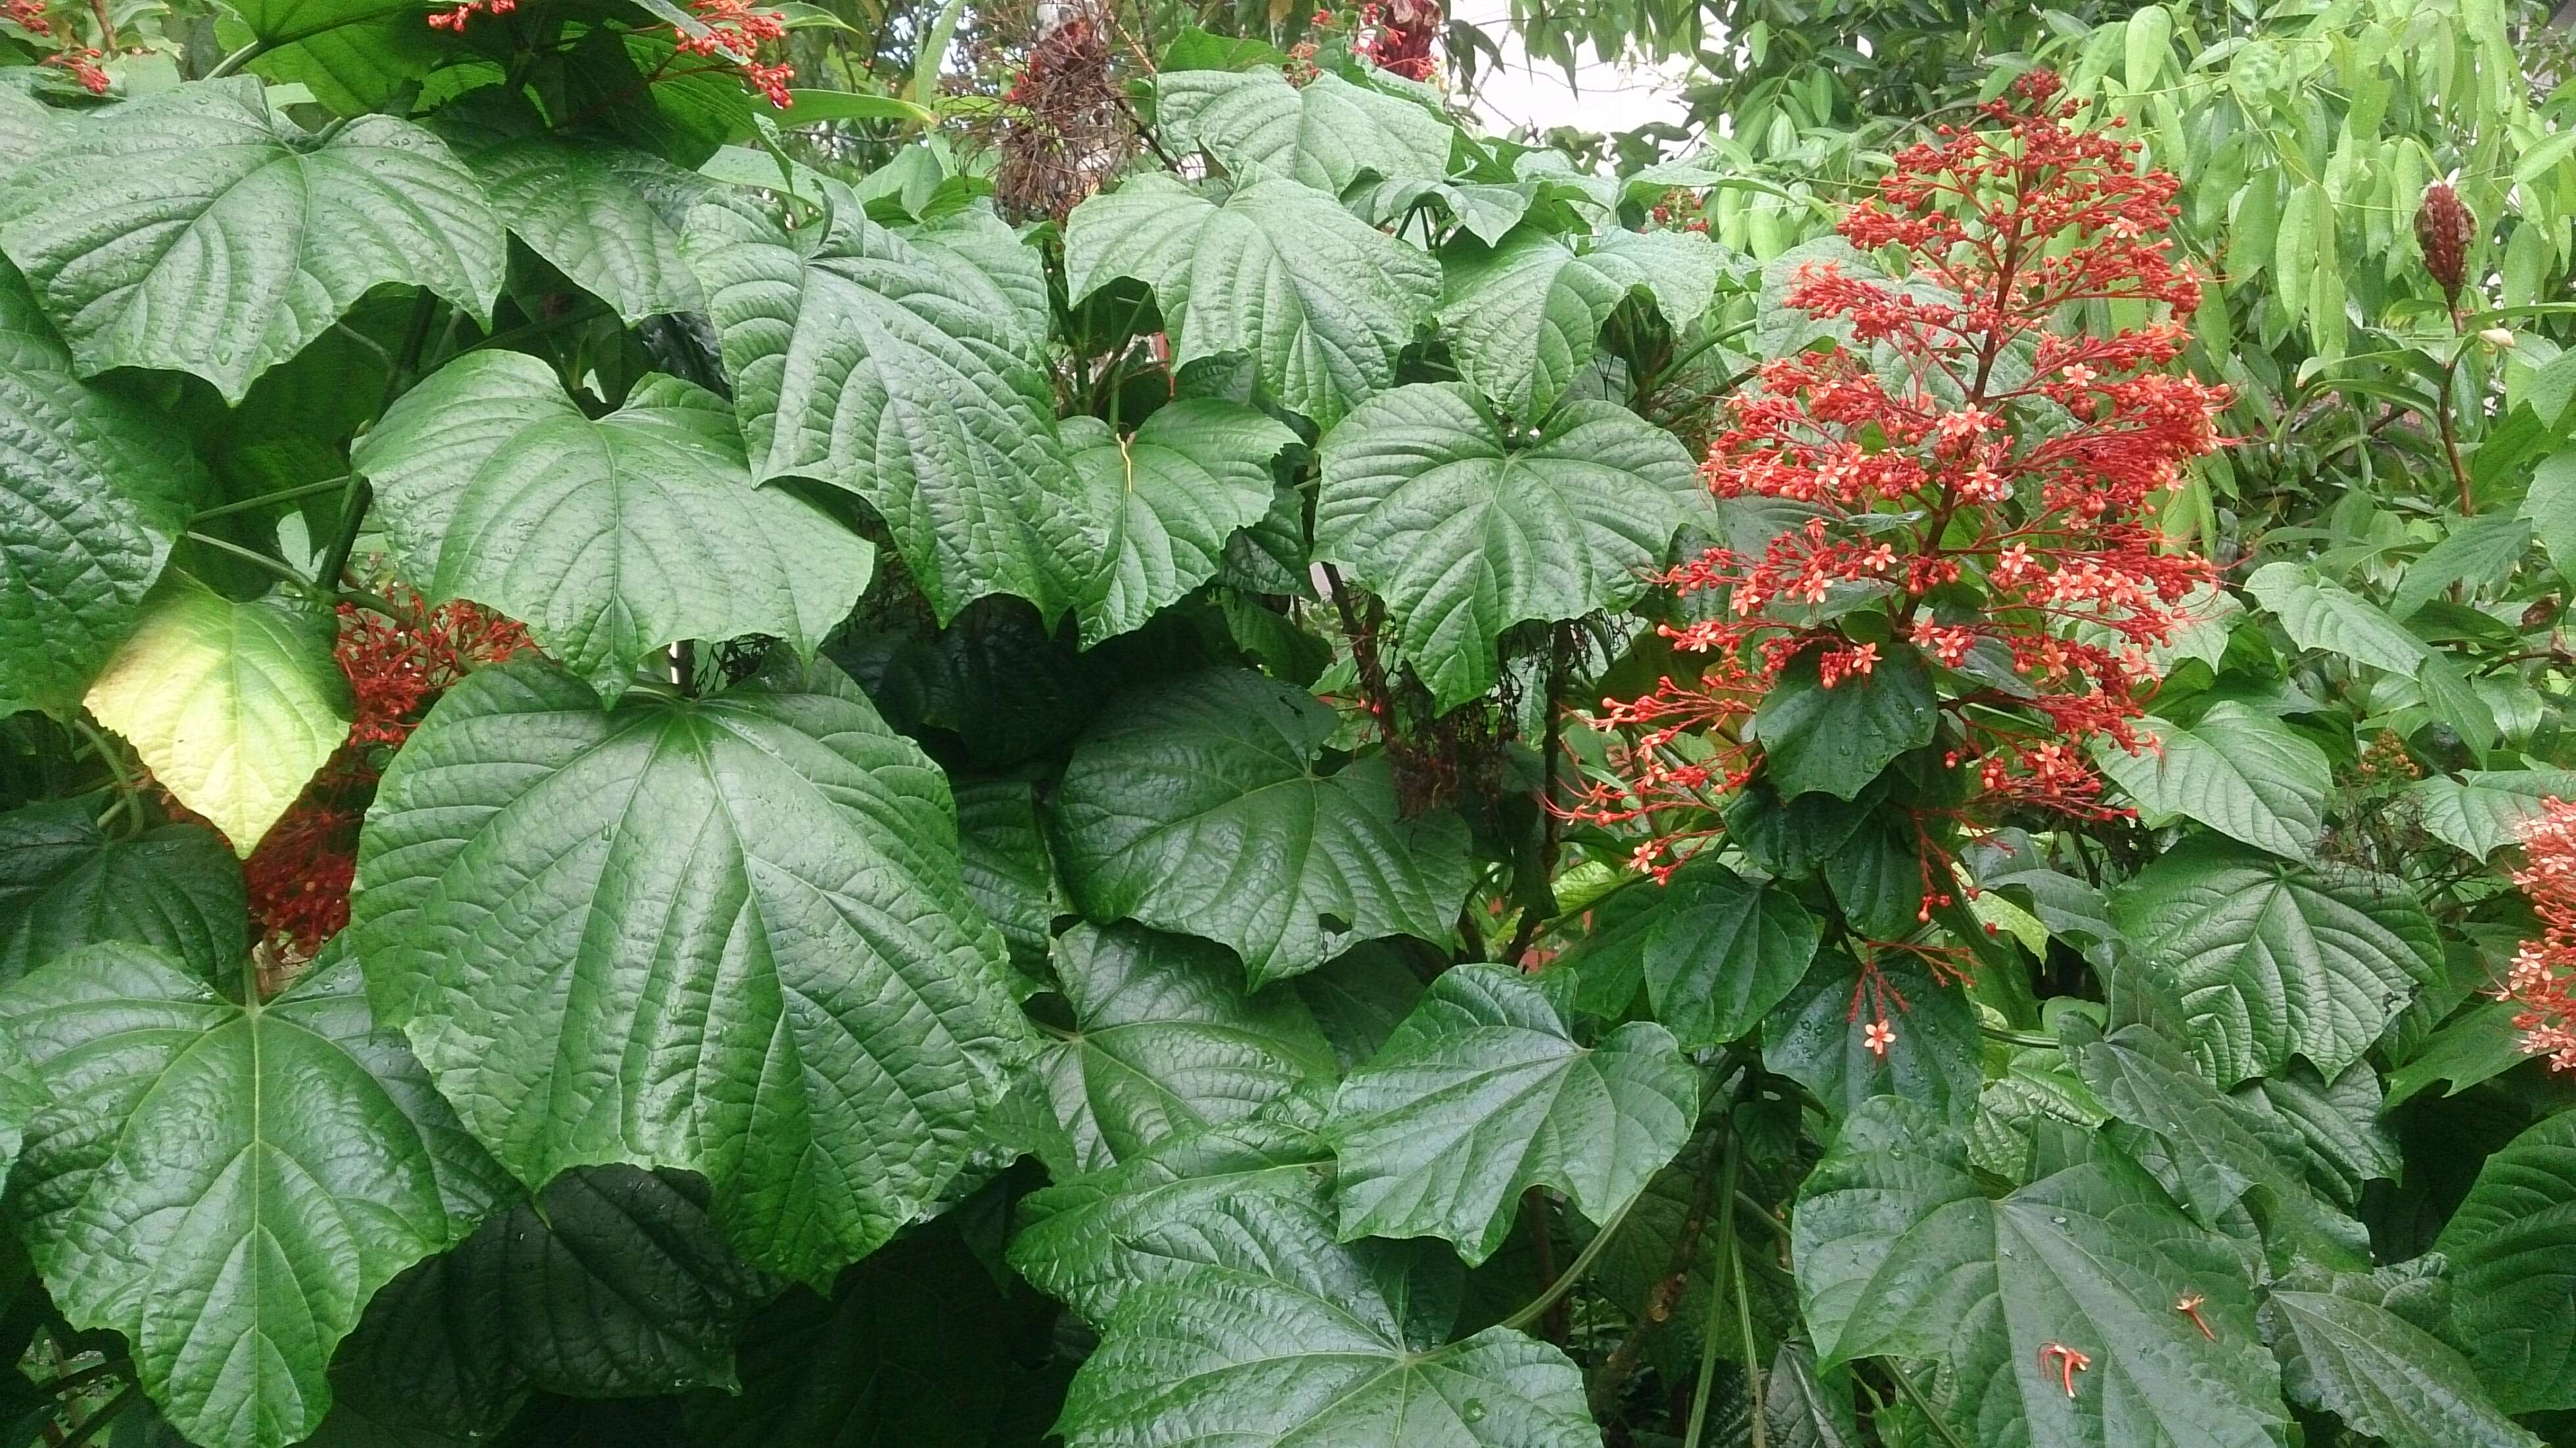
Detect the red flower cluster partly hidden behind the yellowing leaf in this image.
<box><xmin>242</xmin><ymin>587</ymin><xmax>531</xmax><ymax>956</ymax></box>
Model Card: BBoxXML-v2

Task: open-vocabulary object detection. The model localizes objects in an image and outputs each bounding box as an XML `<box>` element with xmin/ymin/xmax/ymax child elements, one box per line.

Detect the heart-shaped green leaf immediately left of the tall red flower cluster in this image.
<box><xmin>1314</xmin><ymin>384</ymin><xmax>1697</xmax><ymax>708</ymax></box>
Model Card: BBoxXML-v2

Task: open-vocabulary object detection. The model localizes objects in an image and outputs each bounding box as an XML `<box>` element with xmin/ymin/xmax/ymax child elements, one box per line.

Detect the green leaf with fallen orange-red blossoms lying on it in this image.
<box><xmin>1793</xmin><ymin>1100</ymin><xmax>2288</xmax><ymax>1448</ymax></box>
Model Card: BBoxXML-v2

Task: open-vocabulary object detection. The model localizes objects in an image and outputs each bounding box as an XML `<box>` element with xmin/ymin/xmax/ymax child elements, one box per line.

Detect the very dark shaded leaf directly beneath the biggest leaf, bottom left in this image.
<box><xmin>325</xmin><ymin>1167</ymin><xmax>778</xmax><ymax>1443</ymax></box>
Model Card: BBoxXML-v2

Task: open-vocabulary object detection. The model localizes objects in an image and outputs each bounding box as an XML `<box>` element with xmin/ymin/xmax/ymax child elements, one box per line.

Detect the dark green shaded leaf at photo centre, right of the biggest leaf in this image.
<box><xmin>1051</xmin><ymin>670</ymin><xmax>1468</xmax><ymax>987</ymax></box>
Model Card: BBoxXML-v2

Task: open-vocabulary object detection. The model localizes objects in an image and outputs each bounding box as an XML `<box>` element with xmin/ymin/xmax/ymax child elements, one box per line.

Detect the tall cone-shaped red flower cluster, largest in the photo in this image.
<box><xmin>1579</xmin><ymin>72</ymin><xmax>2226</xmax><ymax>891</ymax></box>
